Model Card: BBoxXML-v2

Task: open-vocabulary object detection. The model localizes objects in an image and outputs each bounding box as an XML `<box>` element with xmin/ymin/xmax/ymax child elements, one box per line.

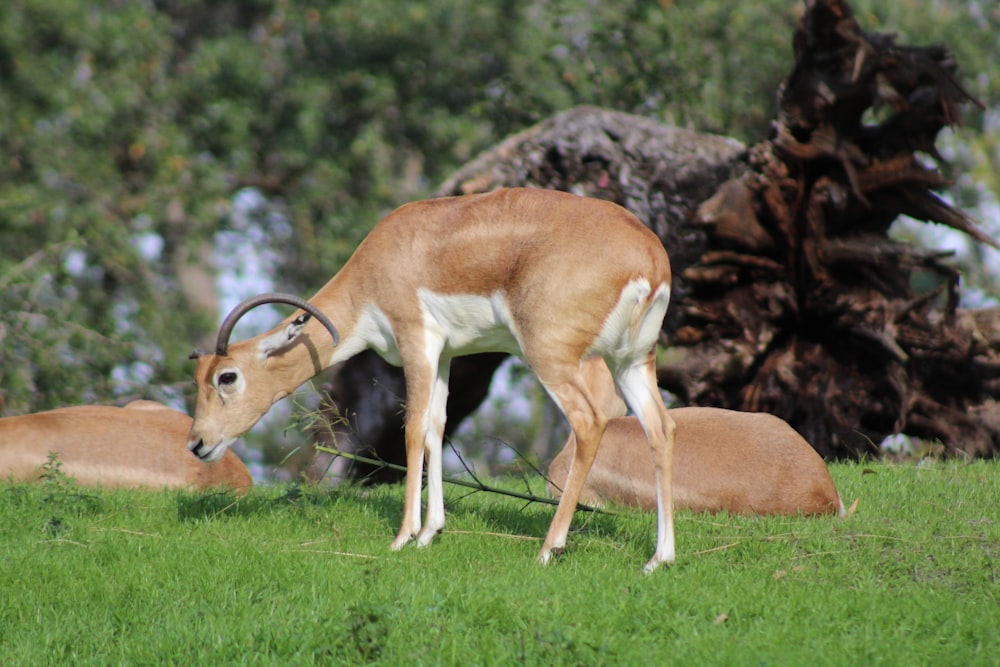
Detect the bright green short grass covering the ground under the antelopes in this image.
<box><xmin>0</xmin><ymin>461</ymin><xmax>1000</xmax><ymax>665</ymax></box>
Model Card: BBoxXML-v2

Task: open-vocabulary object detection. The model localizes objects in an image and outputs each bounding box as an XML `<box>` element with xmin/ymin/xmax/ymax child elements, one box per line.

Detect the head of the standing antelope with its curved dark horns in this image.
<box><xmin>188</xmin><ymin>293</ymin><xmax>340</xmax><ymax>462</ymax></box>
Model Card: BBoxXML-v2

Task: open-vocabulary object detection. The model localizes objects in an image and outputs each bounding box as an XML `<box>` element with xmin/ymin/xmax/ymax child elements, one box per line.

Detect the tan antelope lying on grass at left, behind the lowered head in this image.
<box><xmin>0</xmin><ymin>401</ymin><xmax>253</xmax><ymax>493</ymax></box>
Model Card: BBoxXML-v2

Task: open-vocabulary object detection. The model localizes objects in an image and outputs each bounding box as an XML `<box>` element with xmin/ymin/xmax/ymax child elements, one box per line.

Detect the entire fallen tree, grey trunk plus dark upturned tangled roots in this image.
<box><xmin>318</xmin><ymin>0</ymin><xmax>1000</xmax><ymax>480</ymax></box>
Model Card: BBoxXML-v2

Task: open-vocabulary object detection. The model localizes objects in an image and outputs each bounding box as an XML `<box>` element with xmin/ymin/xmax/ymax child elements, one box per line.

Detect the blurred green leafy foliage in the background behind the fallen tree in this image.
<box><xmin>0</xmin><ymin>0</ymin><xmax>1000</xmax><ymax>414</ymax></box>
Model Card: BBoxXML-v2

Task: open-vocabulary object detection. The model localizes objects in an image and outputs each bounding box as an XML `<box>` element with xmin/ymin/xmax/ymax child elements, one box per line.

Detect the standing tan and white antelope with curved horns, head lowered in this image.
<box><xmin>189</xmin><ymin>189</ymin><xmax>675</xmax><ymax>571</ymax></box>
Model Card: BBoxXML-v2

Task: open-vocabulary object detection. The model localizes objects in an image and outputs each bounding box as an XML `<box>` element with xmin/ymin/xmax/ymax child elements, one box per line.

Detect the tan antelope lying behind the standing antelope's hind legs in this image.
<box><xmin>549</xmin><ymin>408</ymin><xmax>844</xmax><ymax>515</ymax></box>
